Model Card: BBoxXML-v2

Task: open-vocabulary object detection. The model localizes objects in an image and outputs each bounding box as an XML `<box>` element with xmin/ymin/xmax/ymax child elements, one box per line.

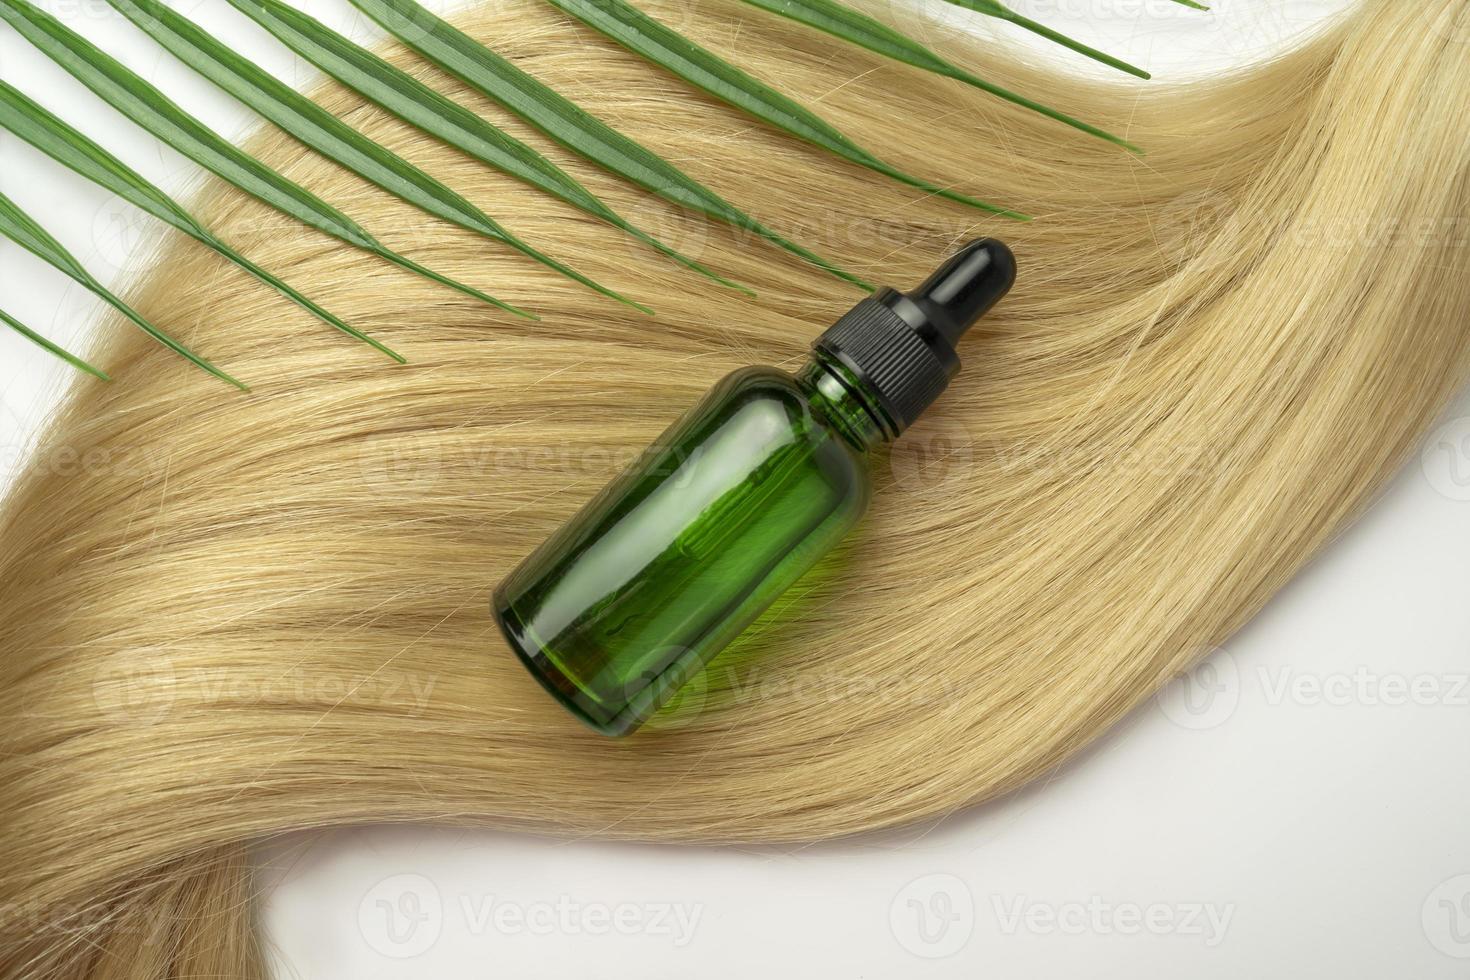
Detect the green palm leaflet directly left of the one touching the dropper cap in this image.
<box><xmin>229</xmin><ymin>0</ymin><xmax>750</xmax><ymax>292</ymax></box>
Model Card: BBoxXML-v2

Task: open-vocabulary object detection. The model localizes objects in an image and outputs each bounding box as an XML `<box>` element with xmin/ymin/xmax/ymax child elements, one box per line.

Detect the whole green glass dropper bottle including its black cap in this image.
<box><xmin>494</xmin><ymin>239</ymin><xmax>1016</xmax><ymax>735</ymax></box>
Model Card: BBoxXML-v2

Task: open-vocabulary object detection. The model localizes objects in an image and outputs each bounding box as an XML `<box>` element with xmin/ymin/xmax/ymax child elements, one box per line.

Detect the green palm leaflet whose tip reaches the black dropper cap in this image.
<box><xmin>343</xmin><ymin>0</ymin><xmax>873</xmax><ymax>291</ymax></box>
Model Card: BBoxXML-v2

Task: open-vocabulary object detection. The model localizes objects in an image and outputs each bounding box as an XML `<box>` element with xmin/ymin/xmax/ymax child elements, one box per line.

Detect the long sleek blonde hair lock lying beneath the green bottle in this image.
<box><xmin>0</xmin><ymin>0</ymin><xmax>1470</xmax><ymax>980</ymax></box>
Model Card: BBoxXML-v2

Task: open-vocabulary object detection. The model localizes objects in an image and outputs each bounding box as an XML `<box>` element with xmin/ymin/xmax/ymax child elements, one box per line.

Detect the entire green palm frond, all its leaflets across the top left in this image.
<box><xmin>0</xmin><ymin>0</ymin><xmax>1208</xmax><ymax>388</ymax></box>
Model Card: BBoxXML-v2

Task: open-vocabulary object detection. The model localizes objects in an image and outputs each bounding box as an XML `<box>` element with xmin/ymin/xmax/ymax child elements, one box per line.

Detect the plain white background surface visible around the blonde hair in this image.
<box><xmin>0</xmin><ymin>0</ymin><xmax>1470</xmax><ymax>980</ymax></box>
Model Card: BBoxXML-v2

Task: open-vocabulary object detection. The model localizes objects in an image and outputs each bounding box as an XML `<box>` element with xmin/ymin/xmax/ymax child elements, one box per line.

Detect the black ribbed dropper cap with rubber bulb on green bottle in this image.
<box><xmin>811</xmin><ymin>238</ymin><xmax>1016</xmax><ymax>436</ymax></box>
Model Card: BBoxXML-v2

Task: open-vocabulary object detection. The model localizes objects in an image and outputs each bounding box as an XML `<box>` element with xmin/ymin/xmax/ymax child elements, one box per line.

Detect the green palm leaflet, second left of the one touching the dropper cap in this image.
<box><xmin>107</xmin><ymin>0</ymin><xmax>651</xmax><ymax>313</ymax></box>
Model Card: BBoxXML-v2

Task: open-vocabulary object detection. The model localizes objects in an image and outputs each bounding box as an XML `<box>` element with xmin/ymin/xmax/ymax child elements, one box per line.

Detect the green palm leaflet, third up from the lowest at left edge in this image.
<box><xmin>0</xmin><ymin>81</ymin><xmax>403</xmax><ymax>363</ymax></box>
